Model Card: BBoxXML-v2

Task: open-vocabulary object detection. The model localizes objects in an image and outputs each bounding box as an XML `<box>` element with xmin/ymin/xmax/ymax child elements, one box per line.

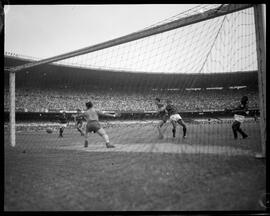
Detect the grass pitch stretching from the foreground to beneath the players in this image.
<box><xmin>4</xmin><ymin>121</ymin><xmax>266</xmax><ymax>211</ymax></box>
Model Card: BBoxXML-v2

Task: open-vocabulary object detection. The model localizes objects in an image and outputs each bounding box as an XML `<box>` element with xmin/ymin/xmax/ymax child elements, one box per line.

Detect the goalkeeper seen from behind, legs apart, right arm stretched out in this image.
<box><xmin>78</xmin><ymin>101</ymin><xmax>116</xmax><ymax>148</ymax></box>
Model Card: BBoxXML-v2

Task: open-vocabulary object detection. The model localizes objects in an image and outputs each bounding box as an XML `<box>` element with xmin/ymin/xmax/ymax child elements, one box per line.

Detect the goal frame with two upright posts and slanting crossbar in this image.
<box><xmin>8</xmin><ymin>4</ymin><xmax>267</xmax><ymax>157</ymax></box>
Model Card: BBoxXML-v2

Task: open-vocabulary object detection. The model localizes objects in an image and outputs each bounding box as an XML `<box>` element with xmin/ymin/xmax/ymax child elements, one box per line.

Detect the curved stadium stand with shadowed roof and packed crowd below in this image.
<box><xmin>4</xmin><ymin>55</ymin><xmax>259</xmax><ymax>112</ymax></box>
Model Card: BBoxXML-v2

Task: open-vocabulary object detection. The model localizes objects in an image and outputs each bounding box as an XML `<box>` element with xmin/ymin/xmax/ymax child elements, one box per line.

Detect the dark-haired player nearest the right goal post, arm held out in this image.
<box><xmin>225</xmin><ymin>96</ymin><xmax>249</xmax><ymax>139</ymax></box>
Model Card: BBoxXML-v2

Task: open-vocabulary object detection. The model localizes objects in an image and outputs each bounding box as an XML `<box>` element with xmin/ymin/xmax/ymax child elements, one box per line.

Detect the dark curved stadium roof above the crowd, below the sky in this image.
<box><xmin>4</xmin><ymin>56</ymin><xmax>258</xmax><ymax>90</ymax></box>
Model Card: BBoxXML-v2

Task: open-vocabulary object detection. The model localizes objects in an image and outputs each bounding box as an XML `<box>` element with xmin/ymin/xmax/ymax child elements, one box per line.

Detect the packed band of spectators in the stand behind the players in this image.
<box><xmin>4</xmin><ymin>89</ymin><xmax>259</xmax><ymax>112</ymax></box>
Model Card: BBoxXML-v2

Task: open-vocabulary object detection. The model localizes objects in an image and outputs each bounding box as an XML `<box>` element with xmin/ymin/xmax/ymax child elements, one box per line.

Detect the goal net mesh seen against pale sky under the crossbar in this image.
<box><xmin>51</xmin><ymin>5</ymin><xmax>257</xmax><ymax>73</ymax></box>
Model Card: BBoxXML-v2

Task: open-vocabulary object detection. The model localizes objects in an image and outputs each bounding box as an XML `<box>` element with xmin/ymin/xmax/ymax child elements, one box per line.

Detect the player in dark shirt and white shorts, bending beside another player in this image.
<box><xmin>161</xmin><ymin>99</ymin><xmax>187</xmax><ymax>139</ymax></box>
